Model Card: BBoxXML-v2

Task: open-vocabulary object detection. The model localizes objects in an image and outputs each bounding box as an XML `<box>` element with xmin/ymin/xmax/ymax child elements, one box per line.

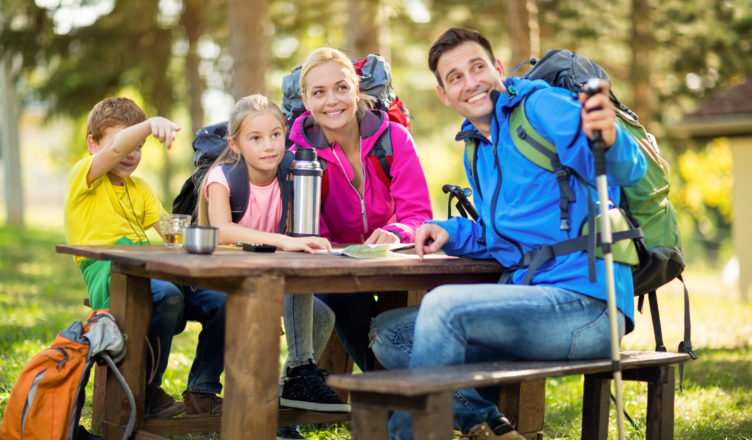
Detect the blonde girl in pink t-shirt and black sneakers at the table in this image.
<box><xmin>199</xmin><ymin>94</ymin><xmax>350</xmax><ymax>422</ymax></box>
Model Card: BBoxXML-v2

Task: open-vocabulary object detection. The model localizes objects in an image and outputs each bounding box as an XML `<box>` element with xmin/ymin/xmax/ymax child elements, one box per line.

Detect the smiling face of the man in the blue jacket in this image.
<box><xmin>436</xmin><ymin>41</ymin><xmax>504</xmax><ymax>128</ymax></box>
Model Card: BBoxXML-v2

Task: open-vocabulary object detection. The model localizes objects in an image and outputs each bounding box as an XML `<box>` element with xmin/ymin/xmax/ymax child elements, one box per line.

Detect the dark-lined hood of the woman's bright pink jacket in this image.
<box><xmin>290</xmin><ymin>109</ymin><xmax>389</xmax><ymax>156</ymax></box>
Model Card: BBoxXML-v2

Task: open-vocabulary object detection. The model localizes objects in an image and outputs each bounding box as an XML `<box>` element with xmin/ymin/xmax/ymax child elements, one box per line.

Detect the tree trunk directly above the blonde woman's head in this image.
<box><xmin>346</xmin><ymin>0</ymin><xmax>391</xmax><ymax>60</ymax></box>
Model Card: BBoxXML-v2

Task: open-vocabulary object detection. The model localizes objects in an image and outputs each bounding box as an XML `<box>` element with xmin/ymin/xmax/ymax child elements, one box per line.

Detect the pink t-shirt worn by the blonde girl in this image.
<box><xmin>204</xmin><ymin>166</ymin><xmax>282</xmax><ymax>233</ymax></box>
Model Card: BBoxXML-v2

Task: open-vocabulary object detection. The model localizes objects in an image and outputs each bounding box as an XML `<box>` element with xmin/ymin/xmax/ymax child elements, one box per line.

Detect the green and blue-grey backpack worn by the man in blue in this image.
<box><xmin>465</xmin><ymin>49</ymin><xmax>696</xmax><ymax>368</ymax></box>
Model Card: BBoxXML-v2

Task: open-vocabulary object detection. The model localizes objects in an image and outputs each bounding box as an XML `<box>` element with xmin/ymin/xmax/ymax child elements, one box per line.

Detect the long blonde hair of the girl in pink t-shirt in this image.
<box><xmin>196</xmin><ymin>93</ymin><xmax>287</xmax><ymax>226</ymax></box>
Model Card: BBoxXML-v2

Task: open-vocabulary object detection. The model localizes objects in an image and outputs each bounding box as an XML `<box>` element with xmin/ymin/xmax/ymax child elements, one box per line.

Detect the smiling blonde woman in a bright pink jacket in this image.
<box><xmin>290</xmin><ymin>47</ymin><xmax>433</xmax><ymax>371</ymax></box>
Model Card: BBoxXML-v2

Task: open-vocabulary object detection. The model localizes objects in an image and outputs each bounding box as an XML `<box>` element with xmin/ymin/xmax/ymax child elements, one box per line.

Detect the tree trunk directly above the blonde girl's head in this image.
<box><xmin>227</xmin><ymin>0</ymin><xmax>271</xmax><ymax>100</ymax></box>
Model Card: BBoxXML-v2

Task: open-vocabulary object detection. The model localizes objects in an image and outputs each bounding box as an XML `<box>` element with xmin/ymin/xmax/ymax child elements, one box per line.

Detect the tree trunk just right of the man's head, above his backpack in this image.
<box><xmin>506</xmin><ymin>0</ymin><xmax>540</xmax><ymax>74</ymax></box>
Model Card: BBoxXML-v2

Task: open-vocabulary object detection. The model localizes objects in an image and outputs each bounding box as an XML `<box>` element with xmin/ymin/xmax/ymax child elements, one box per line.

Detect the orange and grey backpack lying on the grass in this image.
<box><xmin>0</xmin><ymin>310</ymin><xmax>136</xmax><ymax>440</ymax></box>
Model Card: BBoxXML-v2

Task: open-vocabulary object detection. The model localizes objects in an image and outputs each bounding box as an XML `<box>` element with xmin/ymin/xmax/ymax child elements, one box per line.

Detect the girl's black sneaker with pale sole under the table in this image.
<box><xmin>279</xmin><ymin>360</ymin><xmax>350</xmax><ymax>413</ymax></box>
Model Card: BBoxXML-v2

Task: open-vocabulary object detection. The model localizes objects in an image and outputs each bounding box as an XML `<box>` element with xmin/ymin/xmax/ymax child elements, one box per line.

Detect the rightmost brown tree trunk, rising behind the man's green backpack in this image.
<box><xmin>630</xmin><ymin>0</ymin><xmax>655</xmax><ymax>128</ymax></box>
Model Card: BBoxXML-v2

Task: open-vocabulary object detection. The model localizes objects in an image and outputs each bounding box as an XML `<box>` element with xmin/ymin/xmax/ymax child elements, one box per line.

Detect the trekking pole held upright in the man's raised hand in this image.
<box><xmin>583</xmin><ymin>78</ymin><xmax>624</xmax><ymax>440</ymax></box>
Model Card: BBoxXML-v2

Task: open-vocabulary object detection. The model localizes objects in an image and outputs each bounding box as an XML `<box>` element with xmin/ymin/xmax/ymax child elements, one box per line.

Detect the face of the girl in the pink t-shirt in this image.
<box><xmin>228</xmin><ymin>112</ymin><xmax>285</xmax><ymax>186</ymax></box>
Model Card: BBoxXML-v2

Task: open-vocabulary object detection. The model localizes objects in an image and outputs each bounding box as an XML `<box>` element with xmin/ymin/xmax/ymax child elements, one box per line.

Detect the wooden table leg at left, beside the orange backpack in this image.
<box><xmin>102</xmin><ymin>271</ymin><xmax>152</xmax><ymax>438</ymax></box>
